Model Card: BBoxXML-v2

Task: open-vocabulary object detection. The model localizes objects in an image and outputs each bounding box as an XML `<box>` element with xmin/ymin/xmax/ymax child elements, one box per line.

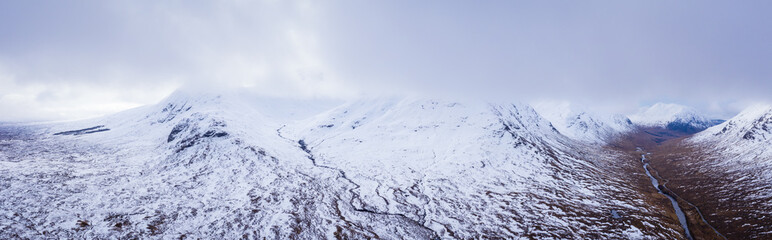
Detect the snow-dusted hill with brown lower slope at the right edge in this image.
<box><xmin>676</xmin><ymin>104</ymin><xmax>772</xmax><ymax>239</ymax></box>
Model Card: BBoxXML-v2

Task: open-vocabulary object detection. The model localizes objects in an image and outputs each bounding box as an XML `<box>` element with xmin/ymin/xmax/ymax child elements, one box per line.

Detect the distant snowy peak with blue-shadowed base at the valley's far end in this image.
<box><xmin>628</xmin><ymin>103</ymin><xmax>721</xmax><ymax>133</ymax></box>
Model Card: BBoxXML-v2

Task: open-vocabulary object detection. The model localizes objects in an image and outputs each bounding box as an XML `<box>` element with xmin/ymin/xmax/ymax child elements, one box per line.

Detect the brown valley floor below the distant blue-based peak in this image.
<box><xmin>612</xmin><ymin>118</ymin><xmax>772</xmax><ymax>239</ymax></box>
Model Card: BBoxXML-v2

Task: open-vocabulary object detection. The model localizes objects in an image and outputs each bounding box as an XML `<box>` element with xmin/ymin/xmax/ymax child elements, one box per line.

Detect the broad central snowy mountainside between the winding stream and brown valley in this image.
<box><xmin>282</xmin><ymin>98</ymin><xmax>678</xmax><ymax>239</ymax></box>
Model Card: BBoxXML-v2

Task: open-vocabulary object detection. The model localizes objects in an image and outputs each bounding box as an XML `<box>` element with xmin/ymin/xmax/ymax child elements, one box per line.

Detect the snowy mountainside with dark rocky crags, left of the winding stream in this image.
<box><xmin>0</xmin><ymin>93</ymin><xmax>432</xmax><ymax>239</ymax></box>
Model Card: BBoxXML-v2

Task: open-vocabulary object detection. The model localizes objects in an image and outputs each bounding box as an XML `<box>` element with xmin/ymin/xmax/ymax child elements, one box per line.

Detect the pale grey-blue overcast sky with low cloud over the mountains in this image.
<box><xmin>0</xmin><ymin>0</ymin><xmax>772</xmax><ymax>121</ymax></box>
